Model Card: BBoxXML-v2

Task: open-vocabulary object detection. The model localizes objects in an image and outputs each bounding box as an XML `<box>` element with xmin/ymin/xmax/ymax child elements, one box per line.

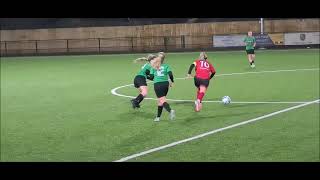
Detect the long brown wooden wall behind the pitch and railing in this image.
<box><xmin>0</xmin><ymin>19</ymin><xmax>320</xmax><ymax>55</ymax></box>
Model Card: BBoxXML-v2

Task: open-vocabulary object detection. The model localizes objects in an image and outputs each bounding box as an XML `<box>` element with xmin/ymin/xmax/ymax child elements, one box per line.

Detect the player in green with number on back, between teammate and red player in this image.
<box><xmin>150</xmin><ymin>52</ymin><xmax>175</xmax><ymax>122</ymax></box>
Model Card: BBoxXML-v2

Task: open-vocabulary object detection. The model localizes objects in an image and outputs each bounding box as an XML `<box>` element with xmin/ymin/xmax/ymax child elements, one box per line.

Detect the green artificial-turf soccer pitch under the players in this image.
<box><xmin>1</xmin><ymin>49</ymin><xmax>320</xmax><ymax>162</ymax></box>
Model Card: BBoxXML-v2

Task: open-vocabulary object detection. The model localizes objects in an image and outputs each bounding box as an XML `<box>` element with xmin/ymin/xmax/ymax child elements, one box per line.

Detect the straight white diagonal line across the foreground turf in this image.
<box><xmin>114</xmin><ymin>99</ymin><xmax>319</xmax><ymax>162</ymax></box>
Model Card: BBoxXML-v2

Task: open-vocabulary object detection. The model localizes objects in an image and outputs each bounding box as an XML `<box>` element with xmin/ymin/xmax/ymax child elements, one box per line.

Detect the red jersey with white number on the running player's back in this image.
<box><xmin>193</xmin><ymin>59</ymin><xmax>216</xmax><ymax>79</ymax></box>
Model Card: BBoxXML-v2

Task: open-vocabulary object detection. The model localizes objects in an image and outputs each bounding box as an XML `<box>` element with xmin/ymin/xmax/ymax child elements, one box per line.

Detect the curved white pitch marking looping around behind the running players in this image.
<box><xmin>111</xmin><ymin>68</ymin><xmax>319</xmax><ymax>104</ymax></box>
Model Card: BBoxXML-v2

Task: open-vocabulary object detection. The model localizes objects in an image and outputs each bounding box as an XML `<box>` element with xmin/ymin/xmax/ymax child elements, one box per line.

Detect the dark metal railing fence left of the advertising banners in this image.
<box><xmin>1</xmin><ymin>36</ymin><xmax>213</xmax><ymax>56</ymax></box>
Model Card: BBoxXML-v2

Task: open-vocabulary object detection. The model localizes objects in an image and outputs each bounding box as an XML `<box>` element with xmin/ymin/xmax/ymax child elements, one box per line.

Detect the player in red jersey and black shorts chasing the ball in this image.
<box><xmin>187</xmin><ymin>52</ymin><xmax>216</xmax><ymax>112</ymax></box>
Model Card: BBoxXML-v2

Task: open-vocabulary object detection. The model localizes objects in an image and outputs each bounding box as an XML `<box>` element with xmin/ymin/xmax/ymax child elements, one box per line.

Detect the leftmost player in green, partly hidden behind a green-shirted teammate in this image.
<box><xmin>131</xmin><ymin>54</ymin><xmax>157</xmax><ymax>109</ymax></box>
